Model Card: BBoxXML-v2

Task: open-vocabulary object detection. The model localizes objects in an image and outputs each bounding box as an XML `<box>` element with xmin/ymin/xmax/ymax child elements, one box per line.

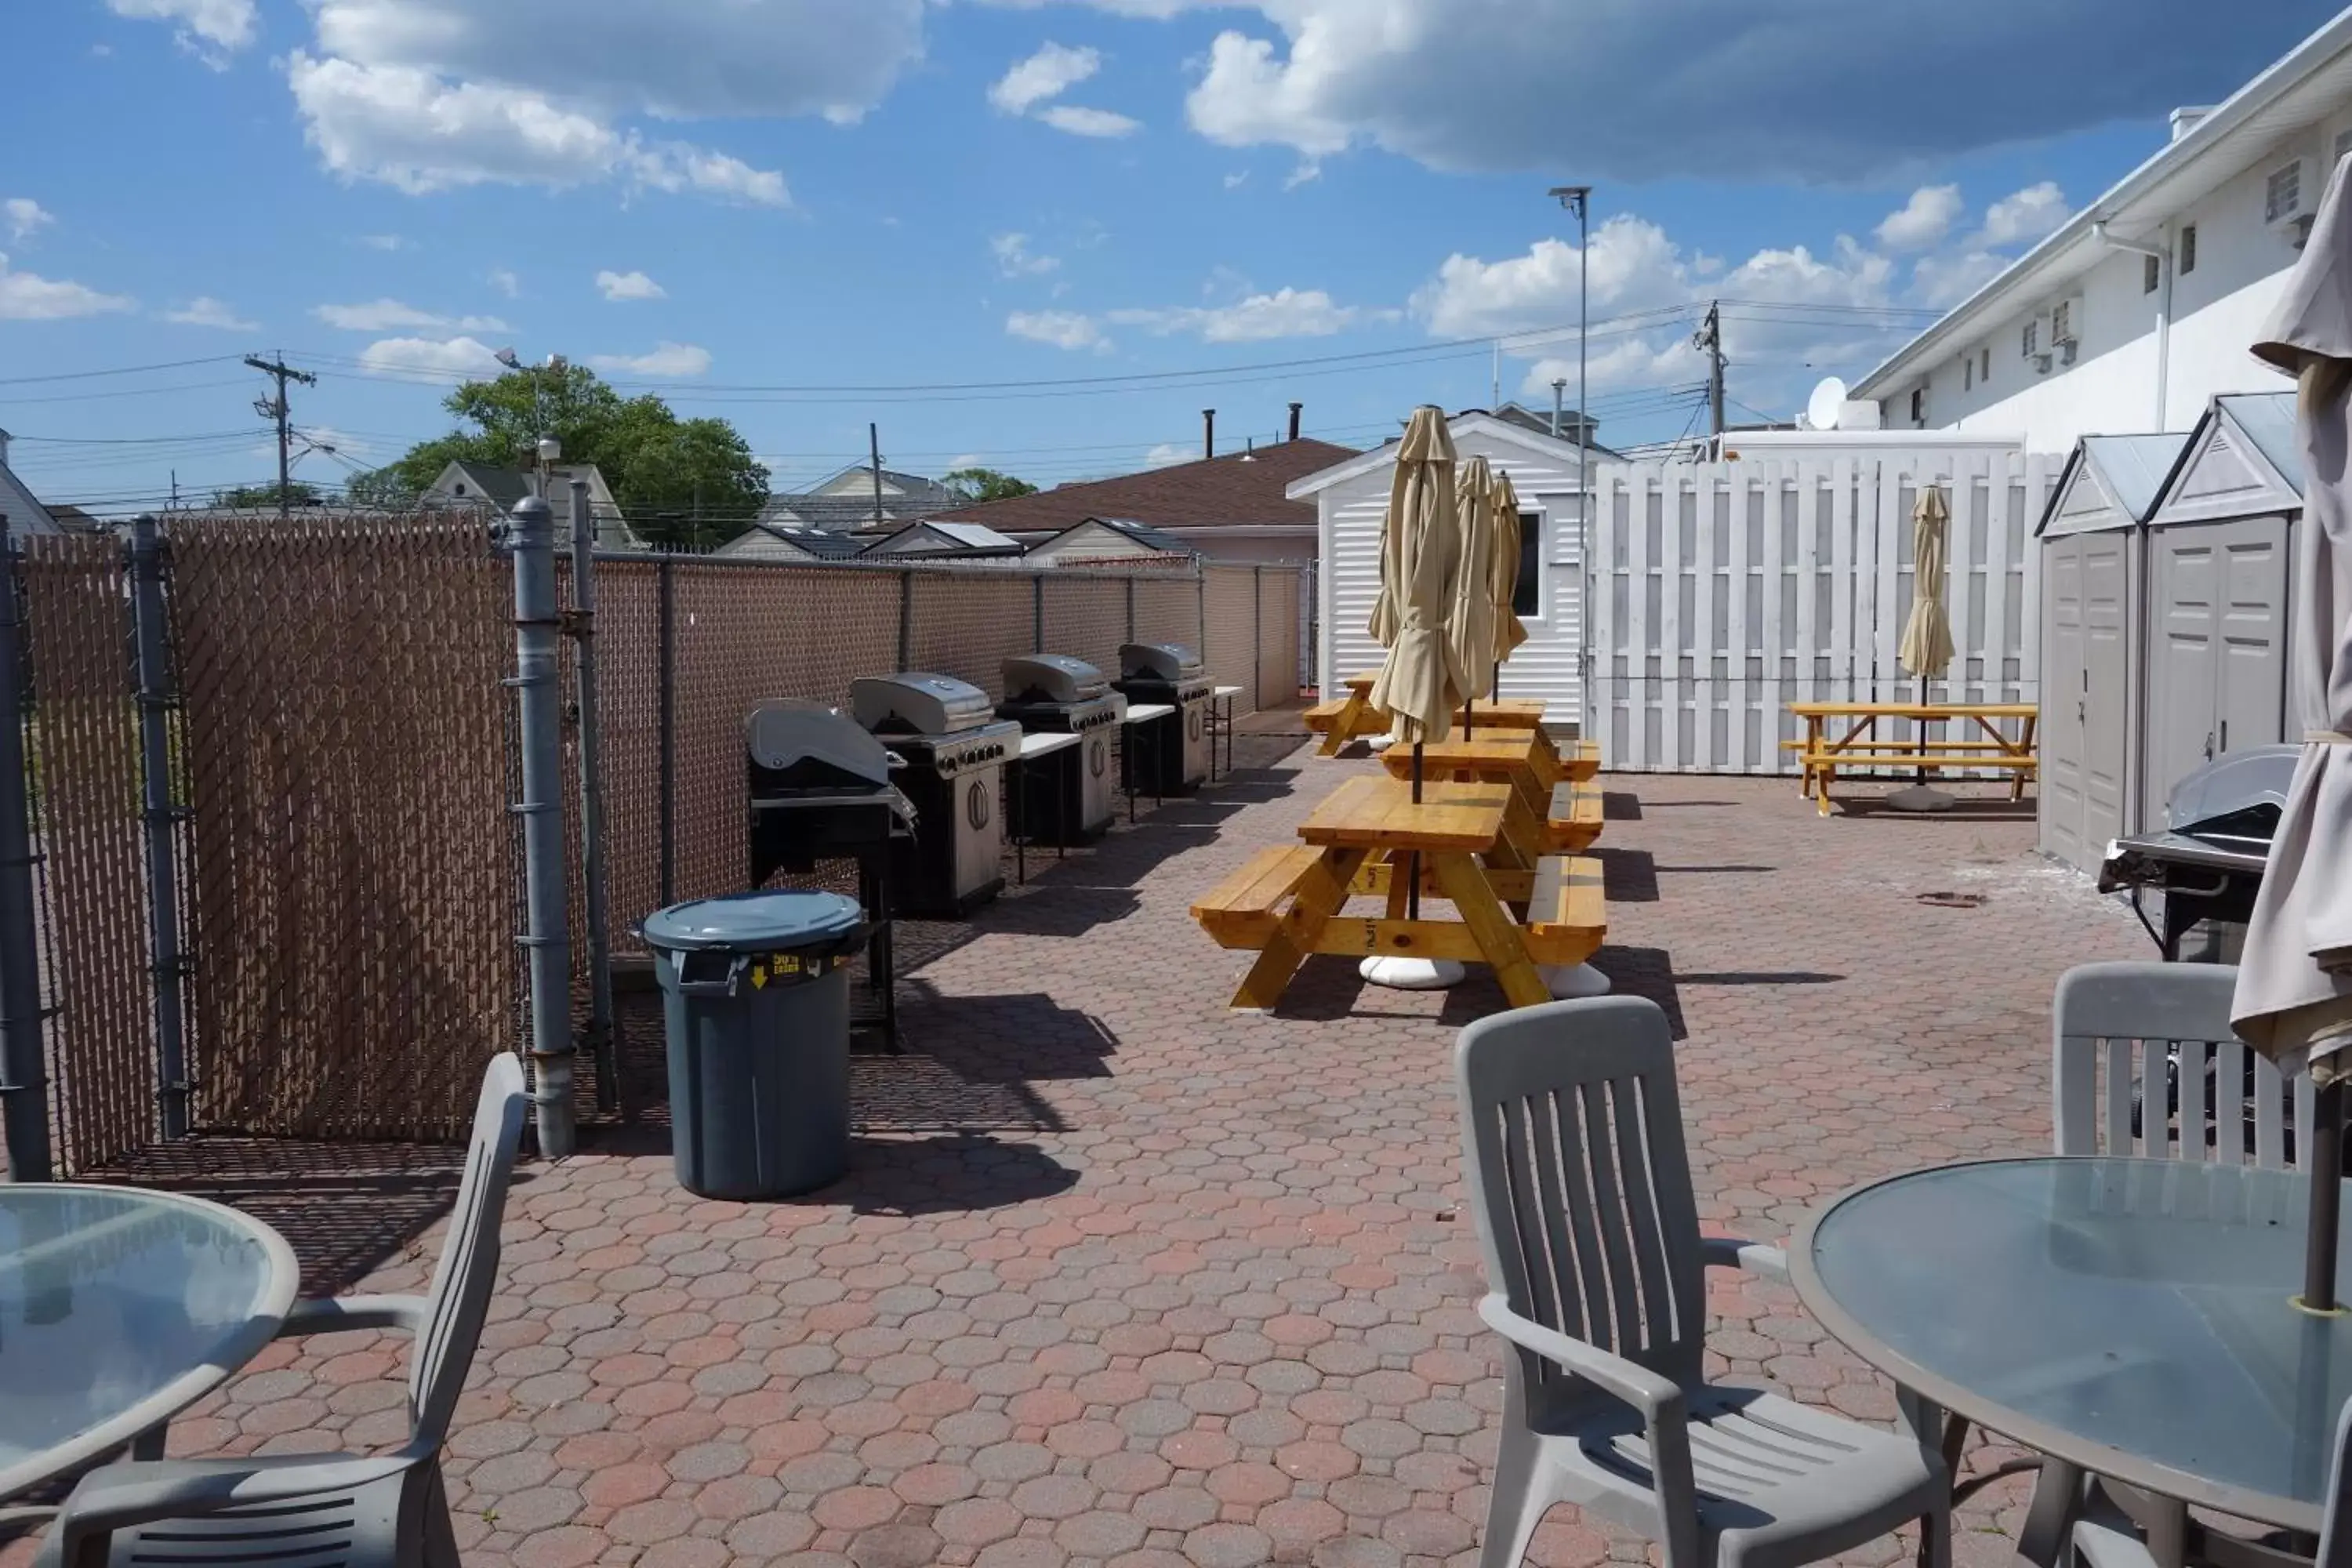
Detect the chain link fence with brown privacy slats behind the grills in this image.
<box><xmin>0</xmin><ymin>515</ymin><xmax>1301</xmax><ymax>1173</ymax></box>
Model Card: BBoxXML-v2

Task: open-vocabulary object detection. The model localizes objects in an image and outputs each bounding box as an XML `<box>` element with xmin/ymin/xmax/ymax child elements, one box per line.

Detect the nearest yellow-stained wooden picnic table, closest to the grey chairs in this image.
<box><xmin>1192</xmin><ymin>774</ymin><xmax>1606</xmax><ymax>1008</ymax></box>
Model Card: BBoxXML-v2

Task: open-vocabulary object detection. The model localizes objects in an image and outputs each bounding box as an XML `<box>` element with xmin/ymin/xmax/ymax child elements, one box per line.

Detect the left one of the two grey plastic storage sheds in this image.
<box><xmin>2037</xmin><ymin>433</ymin><xmax>2190</xmax><ymax>869</ymax></box>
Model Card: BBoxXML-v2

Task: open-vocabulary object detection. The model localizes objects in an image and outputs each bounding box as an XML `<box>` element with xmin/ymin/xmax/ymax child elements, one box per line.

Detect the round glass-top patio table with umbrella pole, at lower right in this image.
<box><xmin>1790</xmin><ymin>1159</ymin><xmax>2352</xmax><ymax>1563</ymax></box>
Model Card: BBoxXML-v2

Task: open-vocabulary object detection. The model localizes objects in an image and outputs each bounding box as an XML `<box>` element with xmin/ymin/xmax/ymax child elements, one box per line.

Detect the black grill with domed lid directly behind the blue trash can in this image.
<box><xmin>743</xmin><ymin>701</ymin><xmax>915</xmax><ymax>1048</ymax></box>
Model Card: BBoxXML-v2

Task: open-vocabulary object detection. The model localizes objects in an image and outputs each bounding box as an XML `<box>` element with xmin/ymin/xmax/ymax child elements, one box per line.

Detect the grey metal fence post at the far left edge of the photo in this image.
<box><xmin>0</xmin><ymin>513</ymin><xmax>54</xmax><ymax>1182</ymax></box>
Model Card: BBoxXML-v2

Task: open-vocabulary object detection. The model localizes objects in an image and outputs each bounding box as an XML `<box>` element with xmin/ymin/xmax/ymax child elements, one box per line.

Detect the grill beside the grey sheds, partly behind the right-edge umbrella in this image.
<box><xmin>2098</xmin><ymin>746</ymin><xmax>2303</xmax><ymax>959</ymax></box>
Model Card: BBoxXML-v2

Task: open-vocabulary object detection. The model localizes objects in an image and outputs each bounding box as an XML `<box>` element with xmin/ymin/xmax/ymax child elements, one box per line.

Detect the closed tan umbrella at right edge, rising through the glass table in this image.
<box><xmin>2230</xmin><ymin>165</ymin><xmax>2352</xmax><ymax>1309</ymax></box>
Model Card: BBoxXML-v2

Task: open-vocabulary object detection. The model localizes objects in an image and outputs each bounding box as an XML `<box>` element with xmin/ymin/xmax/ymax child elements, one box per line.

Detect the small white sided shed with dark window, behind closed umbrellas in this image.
<box><xmin>1284</xmin><ymin>414</ymin><xmax>1606</xmax><ymax>724</ymax></box>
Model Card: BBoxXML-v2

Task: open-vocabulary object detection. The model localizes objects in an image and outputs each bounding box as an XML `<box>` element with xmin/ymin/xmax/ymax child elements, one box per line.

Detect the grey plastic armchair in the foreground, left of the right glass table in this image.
<box><xmin>1454</xmin><ymin>996</ymin><xmax>1952</xmax><ymax>1568</ymax></box>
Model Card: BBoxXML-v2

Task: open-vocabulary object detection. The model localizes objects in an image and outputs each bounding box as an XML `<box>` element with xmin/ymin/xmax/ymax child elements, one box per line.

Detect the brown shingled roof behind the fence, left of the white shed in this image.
<box><xmin>934</xmin><ymin>437</ymin><xmax>1355</xmax><ymax>534</ymax></box>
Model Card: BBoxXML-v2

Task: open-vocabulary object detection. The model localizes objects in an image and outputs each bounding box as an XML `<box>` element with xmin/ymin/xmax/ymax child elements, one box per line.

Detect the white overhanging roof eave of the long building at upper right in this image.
<box><xmin>1853</xmin><ymin>9</ymin><xmax>2352</xmax><ymax>400</ymax></box>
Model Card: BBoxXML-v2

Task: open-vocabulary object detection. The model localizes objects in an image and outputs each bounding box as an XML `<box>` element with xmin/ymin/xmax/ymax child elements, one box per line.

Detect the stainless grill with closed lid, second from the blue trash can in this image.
<box><xmin>849</xmin><ymin>670</ymin><xmax>1021</xmax><ymax>919</ymax></box>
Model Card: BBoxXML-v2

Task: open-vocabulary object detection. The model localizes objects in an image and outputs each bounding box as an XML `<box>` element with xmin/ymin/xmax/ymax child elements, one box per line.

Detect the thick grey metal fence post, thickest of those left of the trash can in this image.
<box><xmin>508</xmin><ymin>496</ymin><xmax>576</xmax><ymax>1159</ymax></box>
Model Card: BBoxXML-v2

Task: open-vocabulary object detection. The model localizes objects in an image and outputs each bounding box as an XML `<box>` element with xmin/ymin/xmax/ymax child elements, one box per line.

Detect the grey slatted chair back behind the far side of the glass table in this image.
<box><xmin>2051</xmin><ymin>964</ymin><xmax>2312</xmax><ymax>1168</ymax></box>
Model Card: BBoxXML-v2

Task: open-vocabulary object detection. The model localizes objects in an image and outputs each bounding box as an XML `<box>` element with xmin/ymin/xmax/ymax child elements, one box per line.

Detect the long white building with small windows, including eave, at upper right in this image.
<box><xmin>1853</xmin><ymin>9</ymin><xmax>2352</xmax><ymax>452</ymax></box>
